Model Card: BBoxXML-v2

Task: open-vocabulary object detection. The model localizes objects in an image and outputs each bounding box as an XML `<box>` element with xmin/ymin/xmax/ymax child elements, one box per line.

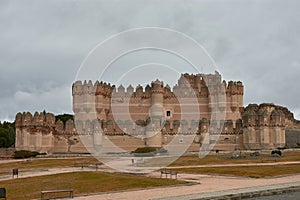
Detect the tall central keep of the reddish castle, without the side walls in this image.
<box><xmin>72</xmin><ymin>72</ymin><xmax>244</xmax><ymax>151</ymax></box>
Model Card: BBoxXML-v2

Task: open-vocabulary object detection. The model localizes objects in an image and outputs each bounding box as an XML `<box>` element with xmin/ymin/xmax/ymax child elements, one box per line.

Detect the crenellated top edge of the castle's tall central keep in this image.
<box><xmin>72</xmin><ymin>71</ymin><xmax>244</xmax><ymax>98</ymax></box>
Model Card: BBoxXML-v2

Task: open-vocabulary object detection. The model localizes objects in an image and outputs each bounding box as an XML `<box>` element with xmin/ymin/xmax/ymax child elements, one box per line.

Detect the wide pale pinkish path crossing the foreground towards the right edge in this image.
<box><xmin>75</xmin><ymin>173</ymin><xmax>300</xmax><ymax>200</ymax></box>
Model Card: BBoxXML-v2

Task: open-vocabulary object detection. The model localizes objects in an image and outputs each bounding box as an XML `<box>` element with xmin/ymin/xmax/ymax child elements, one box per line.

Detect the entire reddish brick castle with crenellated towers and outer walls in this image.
<box><xmin>16</xmin><ymin>72</ymin><xmax>300</xmax><ymax>153</ymax></box>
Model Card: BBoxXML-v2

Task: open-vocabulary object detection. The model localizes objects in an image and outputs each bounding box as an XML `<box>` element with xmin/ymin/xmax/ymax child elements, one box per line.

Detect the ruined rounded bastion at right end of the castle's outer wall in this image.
<box><xmin>242</xmin><ymin>103</ymin><xmax>300</xmax><ymax>149</ymax></box>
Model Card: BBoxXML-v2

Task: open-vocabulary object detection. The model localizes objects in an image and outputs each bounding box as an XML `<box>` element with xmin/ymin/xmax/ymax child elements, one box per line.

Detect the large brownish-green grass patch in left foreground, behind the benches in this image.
<box><xmin>0</xmin><ymin>172</ymin><xmax>186</xmax><ymax>200</ymax></box>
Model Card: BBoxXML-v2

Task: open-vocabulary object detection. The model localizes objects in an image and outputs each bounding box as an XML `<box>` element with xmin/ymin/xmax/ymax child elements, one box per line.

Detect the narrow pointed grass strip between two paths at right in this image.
<box><xmin>172</xmin><ymin>164</ymin><xmax>300</xmax><ymax>178</ymax></box>
